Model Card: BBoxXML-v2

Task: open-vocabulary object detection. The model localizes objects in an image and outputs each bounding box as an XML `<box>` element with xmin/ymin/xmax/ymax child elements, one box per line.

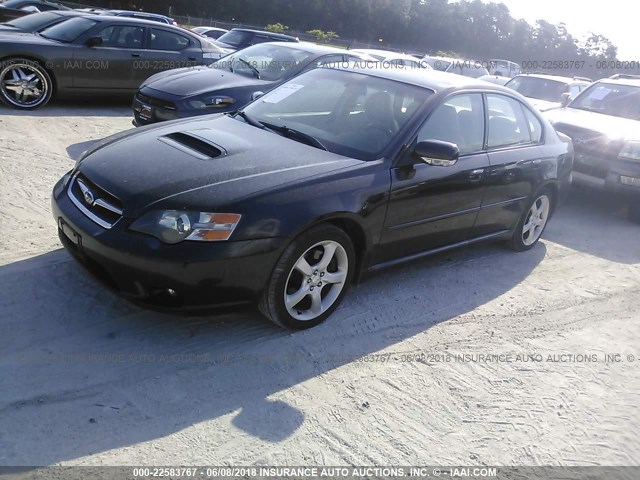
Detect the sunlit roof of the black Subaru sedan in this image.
<box><xmin>334</xmin><ymin>63</ymin><xmax>513</xmax><ymax>93</ymax></box>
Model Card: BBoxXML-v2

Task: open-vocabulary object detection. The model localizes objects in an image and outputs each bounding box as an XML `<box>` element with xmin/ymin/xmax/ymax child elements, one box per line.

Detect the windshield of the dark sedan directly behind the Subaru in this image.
<box><xmin>212</xmin><ymin>43</ymin><xmax>313</xmax><ymax>81</ymax></box>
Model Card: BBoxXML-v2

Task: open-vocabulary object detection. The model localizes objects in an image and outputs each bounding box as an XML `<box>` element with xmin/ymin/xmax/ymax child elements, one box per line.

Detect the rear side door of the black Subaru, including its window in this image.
<box><xmin>474</xmin><ymin>93</ymin><xmax>547</xmax><ymax>235</ymax></box>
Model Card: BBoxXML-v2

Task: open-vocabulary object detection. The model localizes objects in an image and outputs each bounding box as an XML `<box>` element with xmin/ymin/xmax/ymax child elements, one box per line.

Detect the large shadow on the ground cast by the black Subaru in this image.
<box><xmin>0</xmin><ymin>238</ymin><xmax>546</xmax><ymax>465</ymax></box>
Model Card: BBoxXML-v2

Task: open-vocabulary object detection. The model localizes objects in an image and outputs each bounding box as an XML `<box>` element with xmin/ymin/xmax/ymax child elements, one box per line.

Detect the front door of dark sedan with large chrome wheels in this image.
<box><xmin>71</xmin><ymin>24</ymin><xmax>146</xmax><ymax>91</ymax></box>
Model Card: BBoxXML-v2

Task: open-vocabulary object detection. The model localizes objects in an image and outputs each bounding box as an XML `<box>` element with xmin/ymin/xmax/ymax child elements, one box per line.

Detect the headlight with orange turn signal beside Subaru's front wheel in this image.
<box><xmin>129</xmin><ymin>210</ymin><xmax>242</xmax><ymax>244</ymax></box>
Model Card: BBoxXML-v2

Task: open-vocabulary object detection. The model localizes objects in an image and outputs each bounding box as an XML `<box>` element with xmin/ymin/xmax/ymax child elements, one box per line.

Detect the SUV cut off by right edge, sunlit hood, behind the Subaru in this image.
<box><xmin>545</xmin><ymin>75</ymin><xmax>640</xmax><ymax>222</ymax></box>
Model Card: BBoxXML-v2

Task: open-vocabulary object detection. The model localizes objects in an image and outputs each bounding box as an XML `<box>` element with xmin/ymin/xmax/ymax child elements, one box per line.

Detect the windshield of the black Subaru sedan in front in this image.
<box><xmin>245</xmin><ymin>68</ymin><xmax>433</xmax><ymax>160</ymax></box>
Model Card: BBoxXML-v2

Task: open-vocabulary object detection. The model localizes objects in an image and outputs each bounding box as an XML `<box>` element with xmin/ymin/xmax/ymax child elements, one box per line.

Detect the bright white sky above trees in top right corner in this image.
<box><xmin>483</xmin><ymin>0</ymin><xmax>640</xmax><ymax>61</ymax></box>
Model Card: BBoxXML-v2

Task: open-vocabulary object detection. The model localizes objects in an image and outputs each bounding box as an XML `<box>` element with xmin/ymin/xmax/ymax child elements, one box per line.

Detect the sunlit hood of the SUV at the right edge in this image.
<box><xmin>545</xmin><ymin>108</ymin><xmax>640</xmax><ymax>140</ymax></box>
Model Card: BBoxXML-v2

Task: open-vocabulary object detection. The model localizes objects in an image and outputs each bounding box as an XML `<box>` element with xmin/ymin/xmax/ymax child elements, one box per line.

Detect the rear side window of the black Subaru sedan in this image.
<box><xmin>487</xmin><ymin>94</ymin><xmax>531</xmax><ymax>148</ymax></box>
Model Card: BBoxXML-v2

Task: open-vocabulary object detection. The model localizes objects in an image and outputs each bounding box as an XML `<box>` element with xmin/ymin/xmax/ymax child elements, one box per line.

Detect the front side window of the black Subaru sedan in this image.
<box><xmin>418</xmin><ymin>93</ymin><xmax>485</xmax><ymax>155</ymax></box>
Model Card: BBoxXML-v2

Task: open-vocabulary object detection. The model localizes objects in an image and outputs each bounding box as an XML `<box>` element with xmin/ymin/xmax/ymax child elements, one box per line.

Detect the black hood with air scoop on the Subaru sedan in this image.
<box><xmin>77</xmin><ymin>115</ymin><xmax>363</xmax><ymax>217</ymax></box>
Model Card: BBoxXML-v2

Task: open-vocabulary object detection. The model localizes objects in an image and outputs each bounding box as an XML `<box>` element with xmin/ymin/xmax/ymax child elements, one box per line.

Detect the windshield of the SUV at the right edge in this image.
<box><xmin>569</xmin><ymin>82</ymin><xmax>640</xmax><ymax>120</ymax></box>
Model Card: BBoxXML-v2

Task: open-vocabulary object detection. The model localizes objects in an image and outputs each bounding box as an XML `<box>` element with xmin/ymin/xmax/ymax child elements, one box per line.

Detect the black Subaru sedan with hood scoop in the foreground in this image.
<box><xmin>52</xmin><ymin>66</ymin><xmax>573</xmax><ymax>329</ymax></box>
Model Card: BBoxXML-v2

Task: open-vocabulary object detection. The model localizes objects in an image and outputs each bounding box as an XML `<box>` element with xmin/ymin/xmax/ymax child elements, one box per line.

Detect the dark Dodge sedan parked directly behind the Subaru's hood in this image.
<box><xmin>133</xmin><ymin>42</ymin><xmax>372</xmax><ymax>125</ymax></box>
